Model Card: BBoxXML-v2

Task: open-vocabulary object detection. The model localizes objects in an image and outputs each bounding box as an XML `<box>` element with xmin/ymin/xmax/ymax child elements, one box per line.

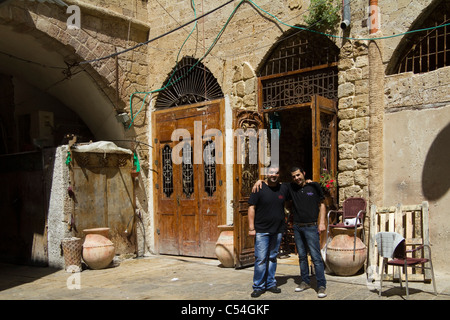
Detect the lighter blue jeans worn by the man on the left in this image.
<box><xmin>253</xmin><ymin>233</ymin><xmax>282</xmax><ymax>290</ymax></box>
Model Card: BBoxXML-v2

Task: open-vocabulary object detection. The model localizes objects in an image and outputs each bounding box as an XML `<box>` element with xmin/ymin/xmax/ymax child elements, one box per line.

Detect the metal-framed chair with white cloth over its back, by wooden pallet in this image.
<box><xmin>375</xmin><ymin>232</ymin><xmax>437</xmax><ymax>299</ymax></box>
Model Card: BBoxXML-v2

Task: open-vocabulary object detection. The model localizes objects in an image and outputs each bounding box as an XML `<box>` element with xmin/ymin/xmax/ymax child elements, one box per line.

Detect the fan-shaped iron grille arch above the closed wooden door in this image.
<box><xmin>155</xmin><ymin>57</ymin><xmax>223</xmax><ymax>108</ymax></box>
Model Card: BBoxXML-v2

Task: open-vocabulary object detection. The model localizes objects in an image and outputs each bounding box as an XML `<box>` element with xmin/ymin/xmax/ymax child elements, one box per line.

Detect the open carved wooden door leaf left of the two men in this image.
<box><xmin>233</xmin><ymin>111</ymin><xmax>263</xmax><ymax>268</ymax></box>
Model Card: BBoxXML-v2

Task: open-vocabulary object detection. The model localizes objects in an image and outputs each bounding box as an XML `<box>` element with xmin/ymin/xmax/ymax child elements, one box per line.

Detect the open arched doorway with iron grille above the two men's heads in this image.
<box><xmin>257</xmin><ymin>30</ymin><xmax>340</xmax><ymax>184</ymax></box>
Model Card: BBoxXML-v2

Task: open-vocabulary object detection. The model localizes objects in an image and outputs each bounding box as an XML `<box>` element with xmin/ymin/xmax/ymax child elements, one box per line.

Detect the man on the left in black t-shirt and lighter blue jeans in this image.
<box><xmin>248</xmin><ymin>168</ymin><xmax>289</xmax><ymax>298</ymax></box>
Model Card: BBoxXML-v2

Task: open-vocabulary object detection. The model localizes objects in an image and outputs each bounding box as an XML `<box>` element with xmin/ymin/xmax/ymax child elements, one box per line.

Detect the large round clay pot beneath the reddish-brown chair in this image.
<box><xmin>326</xmin><ymin>234</ymin><xmax>367</xmax><ymax>276</ymax></box>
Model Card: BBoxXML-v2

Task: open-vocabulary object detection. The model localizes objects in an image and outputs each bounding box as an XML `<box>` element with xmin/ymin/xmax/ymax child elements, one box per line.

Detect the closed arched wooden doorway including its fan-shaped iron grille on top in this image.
<box><xmin>152</xmin><ymin>57</ymin><xmax>226</xmax><ymax>258</ymax></box>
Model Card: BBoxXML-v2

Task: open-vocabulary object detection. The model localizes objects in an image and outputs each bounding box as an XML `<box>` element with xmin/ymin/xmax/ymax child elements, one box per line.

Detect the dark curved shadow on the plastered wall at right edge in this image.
<box><xmin>422</xmin><ymin>123</ymin><xmax>450</xmax><ymax>200</ymax></box>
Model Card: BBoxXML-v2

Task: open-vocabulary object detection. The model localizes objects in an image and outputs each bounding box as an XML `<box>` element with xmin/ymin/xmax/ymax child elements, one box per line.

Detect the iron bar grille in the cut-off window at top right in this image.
<box><xmin>394</xmin><ymin>9</ymin><xmax>450</xmax><ymax>73</ymax></box>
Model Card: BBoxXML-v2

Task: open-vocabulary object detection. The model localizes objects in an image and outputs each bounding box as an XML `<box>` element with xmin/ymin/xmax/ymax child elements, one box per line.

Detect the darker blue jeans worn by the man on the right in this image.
<box><xmin>294</xmin><ymin>224</ymin><xmax>327</xmax><ymax>288</ymax></box>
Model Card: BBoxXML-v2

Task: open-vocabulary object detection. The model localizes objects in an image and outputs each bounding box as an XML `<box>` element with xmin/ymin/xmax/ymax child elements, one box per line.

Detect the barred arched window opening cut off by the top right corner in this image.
<box><xmin>386</xmin><ymin>0</ymin><xmax>450</xmax><ymax>75</ymax></box>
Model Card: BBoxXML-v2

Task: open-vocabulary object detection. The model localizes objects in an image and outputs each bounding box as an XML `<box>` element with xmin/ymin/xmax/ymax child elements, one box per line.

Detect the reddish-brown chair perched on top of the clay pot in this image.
<box><xmin>325</xmin><ymin>197</ymin><xmax>367</xmax><ymax>257</ymax></box>
